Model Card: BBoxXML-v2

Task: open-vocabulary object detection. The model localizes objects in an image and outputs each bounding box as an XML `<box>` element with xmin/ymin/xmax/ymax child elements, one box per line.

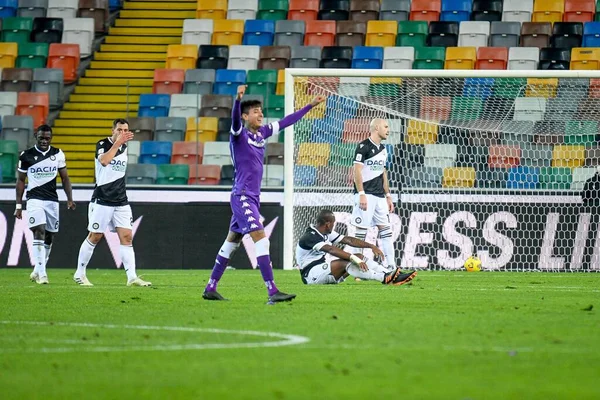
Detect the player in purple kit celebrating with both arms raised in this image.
<box><xmin>202</xmin><ymin>85</ymin><xmax>325</xmax><ymax>304</ymax></box>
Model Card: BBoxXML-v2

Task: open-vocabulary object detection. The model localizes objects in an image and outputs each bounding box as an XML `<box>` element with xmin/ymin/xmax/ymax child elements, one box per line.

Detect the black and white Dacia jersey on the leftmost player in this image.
<box><xmin>17</xmin><ymin>146</ymin><xmax>67</xmax><ymax>201</ymax></box>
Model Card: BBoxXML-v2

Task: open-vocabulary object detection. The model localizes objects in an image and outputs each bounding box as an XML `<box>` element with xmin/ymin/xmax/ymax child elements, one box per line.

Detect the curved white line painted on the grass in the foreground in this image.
<box><xmin>0</xmin><ymin>321</ymin><xmax>310</xmax><ymax>353</ymax></box>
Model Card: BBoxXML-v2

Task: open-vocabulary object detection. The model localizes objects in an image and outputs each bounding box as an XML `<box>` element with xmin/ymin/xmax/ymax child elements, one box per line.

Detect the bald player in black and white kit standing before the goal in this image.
<box><xmin>351</xmin><ymin>118</ymin><xmax>396</xmax><ymax>271</ymax></box>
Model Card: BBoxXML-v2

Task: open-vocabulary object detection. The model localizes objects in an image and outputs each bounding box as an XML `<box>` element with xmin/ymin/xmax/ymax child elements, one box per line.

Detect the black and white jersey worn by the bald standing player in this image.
<box><xmin>354</xmin><ymin>138</ymin><xmax>387</xmax><ymax>197</ymax></box>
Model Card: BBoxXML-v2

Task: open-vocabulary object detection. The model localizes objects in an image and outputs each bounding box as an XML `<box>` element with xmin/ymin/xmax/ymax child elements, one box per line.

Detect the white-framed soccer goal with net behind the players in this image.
<box><xmin>284</xmin><ymin>69</ymin><xmax>600</xmax><ymax>271</ymax></box>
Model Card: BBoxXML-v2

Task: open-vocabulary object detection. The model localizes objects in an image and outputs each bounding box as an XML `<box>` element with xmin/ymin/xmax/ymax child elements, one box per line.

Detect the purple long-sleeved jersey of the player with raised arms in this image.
<box><xmin>229</xmin><ymin>100</ymin><xmax>312</xmax><ymax>196</ymax></box>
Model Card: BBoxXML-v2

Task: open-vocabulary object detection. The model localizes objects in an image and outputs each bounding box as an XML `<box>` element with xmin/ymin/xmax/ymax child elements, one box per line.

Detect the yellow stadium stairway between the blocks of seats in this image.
<box><xmin>53</xmin><ymin>0</ymin><xmax>197</xmax><ymax>183</ymax></box>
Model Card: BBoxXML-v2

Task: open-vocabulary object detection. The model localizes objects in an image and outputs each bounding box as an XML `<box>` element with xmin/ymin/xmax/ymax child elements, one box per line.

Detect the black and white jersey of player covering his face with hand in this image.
<box><xmin>92</xmin><ymin>138</ymin><xmax>128</xmax><ymax>207</ymax></box>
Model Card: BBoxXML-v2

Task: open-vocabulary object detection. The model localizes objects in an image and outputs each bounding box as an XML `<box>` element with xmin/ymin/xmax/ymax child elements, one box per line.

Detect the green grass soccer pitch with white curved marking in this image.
<box><xmin>0</xmin><ymin>268</ymin><xmax>600</xmax><ymax>400</ymax></box>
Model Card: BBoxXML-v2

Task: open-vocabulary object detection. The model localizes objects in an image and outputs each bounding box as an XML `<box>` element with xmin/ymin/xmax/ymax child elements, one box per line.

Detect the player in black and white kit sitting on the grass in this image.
<box><xmin>296</xmin><ymin>210</ymin><xmax>417</xmax><ymax>285</ymax></box>
